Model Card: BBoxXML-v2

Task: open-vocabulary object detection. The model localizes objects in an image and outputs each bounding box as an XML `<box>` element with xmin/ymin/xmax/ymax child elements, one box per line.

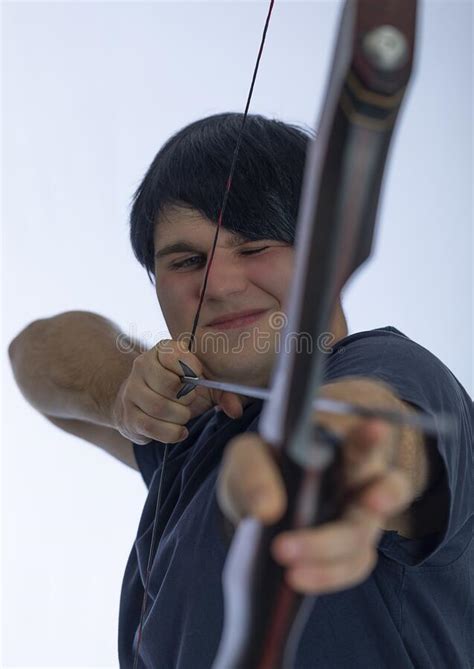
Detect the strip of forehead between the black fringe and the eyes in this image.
<box><xmin>154</xmin><ymin>206</ymin><xmax>245</xmax><ymax>249</ymax></box>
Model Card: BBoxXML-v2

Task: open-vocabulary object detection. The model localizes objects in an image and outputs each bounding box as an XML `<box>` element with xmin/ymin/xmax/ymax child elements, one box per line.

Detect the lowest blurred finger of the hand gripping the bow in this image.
<box><xmin>285</xmin><ymin>548</ymin><xmax>377</xmax><ymax>594</ymax></box>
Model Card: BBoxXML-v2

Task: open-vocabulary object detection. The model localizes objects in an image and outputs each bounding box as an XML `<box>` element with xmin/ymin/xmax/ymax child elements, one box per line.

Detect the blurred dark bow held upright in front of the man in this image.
<box><xmin>214</xmin><ymin>0</ymin><xmax>416</xmax><ymax>669</ymax></box>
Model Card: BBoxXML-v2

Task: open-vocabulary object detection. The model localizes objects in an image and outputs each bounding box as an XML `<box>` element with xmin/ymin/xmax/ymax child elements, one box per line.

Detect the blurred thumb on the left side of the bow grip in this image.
<box><xmin>217</xmin><ymin>434</ymin><xmax>286</xmax><ymax>524</ymax></box>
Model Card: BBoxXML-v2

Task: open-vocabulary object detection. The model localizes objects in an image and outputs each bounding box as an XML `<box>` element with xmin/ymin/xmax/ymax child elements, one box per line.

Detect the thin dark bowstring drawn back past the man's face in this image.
<box><xmin>133</xmin><ymin>0</ymin><xmax>275</xmax><ymax>669</ymax></box>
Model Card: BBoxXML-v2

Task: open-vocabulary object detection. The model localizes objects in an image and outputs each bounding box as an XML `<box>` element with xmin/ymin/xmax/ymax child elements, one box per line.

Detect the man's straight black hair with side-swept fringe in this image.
<box><xmin>130</xmin><ymin>113</ymin><xmax>310</xmax><ymax>281</ymax></box>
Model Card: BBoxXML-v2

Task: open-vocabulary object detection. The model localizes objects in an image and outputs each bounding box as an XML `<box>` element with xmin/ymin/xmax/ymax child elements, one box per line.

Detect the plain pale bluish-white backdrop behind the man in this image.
<box><xmin>2</xmin><ymin>1</ymin><xmax>473</xmax><ymax>667</ymax></box>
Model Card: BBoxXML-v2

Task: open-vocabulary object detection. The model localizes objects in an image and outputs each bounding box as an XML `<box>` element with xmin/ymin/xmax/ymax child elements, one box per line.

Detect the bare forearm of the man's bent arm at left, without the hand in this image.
<box><xmin>9</xmin><ymin>311</ymin><xmax>142</xmax><ymax>427</ymax></box>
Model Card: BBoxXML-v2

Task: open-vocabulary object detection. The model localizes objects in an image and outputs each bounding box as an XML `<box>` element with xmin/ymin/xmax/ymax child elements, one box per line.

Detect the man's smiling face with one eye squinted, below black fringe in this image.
<box><xmin>155</xmin><ymin>207</ymin><xmax>294</xmax><ymax>385</ymax></box>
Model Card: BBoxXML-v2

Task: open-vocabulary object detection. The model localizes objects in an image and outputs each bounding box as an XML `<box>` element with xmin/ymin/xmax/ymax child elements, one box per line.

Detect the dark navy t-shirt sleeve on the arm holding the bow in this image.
<box><xmin>326</xmin><ymin>330</ymin><xmax>474</xmax><ymax>566</ymax></box>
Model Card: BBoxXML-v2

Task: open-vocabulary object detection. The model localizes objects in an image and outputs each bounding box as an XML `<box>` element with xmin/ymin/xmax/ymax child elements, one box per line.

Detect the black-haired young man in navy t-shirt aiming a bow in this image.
<box><xmin>10</xmin><ymin>114</ymin><xmax>473</xmax><ymax>669</ymax></box>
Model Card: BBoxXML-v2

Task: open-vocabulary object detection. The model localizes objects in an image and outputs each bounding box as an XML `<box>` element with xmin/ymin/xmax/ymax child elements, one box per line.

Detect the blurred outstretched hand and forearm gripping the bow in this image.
<box><xmin>217</xmin><ymin>377</ymin><xmax>447</xmax><ymax>594</ymax></box>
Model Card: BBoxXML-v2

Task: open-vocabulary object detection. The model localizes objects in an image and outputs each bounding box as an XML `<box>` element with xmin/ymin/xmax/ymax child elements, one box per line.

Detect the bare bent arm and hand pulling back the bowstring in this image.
<box><xmin>9</xmin><ymin>311</ymin><xmax>242</xmax><ymax>468</ymax></box>
